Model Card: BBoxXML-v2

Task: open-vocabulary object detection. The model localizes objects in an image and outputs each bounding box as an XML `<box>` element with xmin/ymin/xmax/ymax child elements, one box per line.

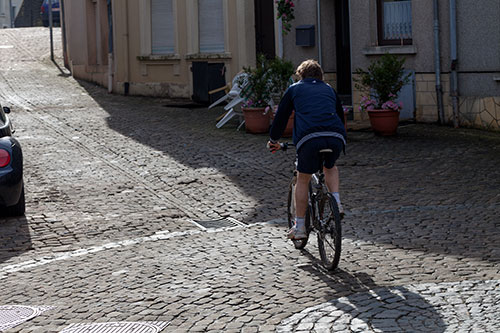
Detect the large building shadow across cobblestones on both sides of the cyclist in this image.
<box><xmin>75</xmin><ymin>81</ymin><xmax>500</xmax><ymax>263</ymax></box>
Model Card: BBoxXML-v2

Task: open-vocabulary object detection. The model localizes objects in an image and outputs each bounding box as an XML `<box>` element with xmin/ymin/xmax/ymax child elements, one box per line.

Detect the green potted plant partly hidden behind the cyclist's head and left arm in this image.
<box><xmin>269</xmin><ymin>58</ymin><xmax>295</xmax><ymax>137</ymax></box>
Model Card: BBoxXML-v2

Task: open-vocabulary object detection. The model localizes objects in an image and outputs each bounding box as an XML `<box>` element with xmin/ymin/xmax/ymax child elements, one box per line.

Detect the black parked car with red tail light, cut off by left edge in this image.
<box><xmin>0</xmin><ymin>106</ymin><xmax>25</xmax><ymax>216</ymax></box>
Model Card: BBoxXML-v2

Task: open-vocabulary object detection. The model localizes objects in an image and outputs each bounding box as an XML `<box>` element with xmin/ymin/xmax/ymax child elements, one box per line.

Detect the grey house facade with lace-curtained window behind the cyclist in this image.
<box><xmin>283</xmin><ymin>0</ymin><xmax>500</xmax><ymax>130</ymax></box>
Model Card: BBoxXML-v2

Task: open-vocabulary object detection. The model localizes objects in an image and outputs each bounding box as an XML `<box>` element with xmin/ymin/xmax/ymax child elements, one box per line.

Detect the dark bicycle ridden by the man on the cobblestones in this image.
<box><xmin>280</xmin><ymin>142</ymin><xmax>342</xmax><ymax>271</ymax></box>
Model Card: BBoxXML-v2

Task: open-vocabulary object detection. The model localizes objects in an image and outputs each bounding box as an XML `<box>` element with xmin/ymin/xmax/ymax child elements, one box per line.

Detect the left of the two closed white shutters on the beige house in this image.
<box><xmin>151</xmin><ymin>0</ymin><xmax>175</xmax><ymax>54</ymax></box>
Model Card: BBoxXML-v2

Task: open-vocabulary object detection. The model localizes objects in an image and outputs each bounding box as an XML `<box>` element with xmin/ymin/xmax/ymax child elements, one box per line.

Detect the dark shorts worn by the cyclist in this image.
<box><xmin>297</xmin><ymin>136</ymin><xmax>344</xmax><ymax>174</ymax></box>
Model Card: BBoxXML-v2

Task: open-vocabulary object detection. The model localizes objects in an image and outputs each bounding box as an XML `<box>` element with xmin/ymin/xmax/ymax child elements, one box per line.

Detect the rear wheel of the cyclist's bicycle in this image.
<box><xmin>317</xmin><ymin>193</ymin><xmax>342</xmax><ymax>271</ymax></box>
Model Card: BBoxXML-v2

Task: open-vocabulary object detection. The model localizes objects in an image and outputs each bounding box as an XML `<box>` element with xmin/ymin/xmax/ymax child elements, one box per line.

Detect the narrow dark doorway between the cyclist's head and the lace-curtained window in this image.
<box><xmin>335</xmin><ymin>0</ymin><xmax>352</xmax><ymax>105</ymax></box>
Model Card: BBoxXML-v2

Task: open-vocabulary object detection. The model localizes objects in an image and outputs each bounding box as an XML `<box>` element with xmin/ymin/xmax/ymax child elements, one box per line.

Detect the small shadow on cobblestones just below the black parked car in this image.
<box><xmin>0</xmin><ymin>216</ymin><xmax>32</xmax><ymax>263</ymax></box>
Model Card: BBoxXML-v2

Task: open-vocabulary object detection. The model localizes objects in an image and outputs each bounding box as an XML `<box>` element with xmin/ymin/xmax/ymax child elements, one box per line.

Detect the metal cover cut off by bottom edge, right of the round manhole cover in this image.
<box><xmin>61</xmin><ymin>321</ymin><xmax>168</xmax><ymax>333</ymax></box>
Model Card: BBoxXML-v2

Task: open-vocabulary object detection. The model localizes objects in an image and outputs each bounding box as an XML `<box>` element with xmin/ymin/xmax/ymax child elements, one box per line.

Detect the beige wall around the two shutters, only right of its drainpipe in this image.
<box><xmin>114</xmin><ymin>0</ymin><xmax>255</xmax><ymax>98</ymax></box>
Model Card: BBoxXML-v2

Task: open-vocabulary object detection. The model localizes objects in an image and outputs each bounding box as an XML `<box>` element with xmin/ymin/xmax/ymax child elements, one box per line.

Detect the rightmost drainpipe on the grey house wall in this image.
<box><xmin>450</xmin><ymin>0</ymin><xmax>458</xmax><ymax>128</ymax></box>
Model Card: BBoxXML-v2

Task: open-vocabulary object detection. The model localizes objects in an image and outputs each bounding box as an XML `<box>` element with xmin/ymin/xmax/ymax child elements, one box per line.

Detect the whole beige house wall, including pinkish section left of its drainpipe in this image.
<box><xmin>65</xmin><ymin>0</ymin><xmax>255</xmax><ymax>98</ymax></box>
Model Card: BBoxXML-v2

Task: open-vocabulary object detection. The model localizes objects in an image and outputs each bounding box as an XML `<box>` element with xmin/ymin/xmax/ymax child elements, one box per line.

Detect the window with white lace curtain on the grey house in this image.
<box><xmin>377</xmin><ymin>0</ymin><xmax>412</xmax><ymax>45</ymax></box>
